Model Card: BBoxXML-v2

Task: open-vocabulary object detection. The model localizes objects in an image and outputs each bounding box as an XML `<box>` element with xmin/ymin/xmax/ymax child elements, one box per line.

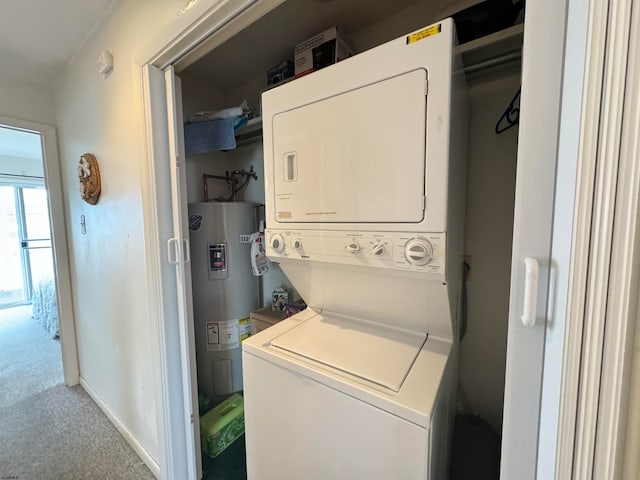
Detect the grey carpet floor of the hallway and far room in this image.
<box><xmin>0</xmin><ymin>307</ymin><xmax>155</xmax><ymax>480</ymax></box>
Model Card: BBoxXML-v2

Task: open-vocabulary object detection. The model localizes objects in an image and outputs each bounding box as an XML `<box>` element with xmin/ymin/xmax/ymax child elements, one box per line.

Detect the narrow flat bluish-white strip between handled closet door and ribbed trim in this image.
<box><xmin>536</xmin><ymin>0</ymin><xmax>589</xmax><ymax>480</ymax></box>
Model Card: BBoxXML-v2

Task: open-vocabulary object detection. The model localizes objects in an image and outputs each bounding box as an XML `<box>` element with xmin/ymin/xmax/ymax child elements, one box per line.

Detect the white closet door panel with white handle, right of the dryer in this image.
<box><xmin>500</xmin><ymin>0</ymin><xmax>567</xmax><ymax>480</ymax></box>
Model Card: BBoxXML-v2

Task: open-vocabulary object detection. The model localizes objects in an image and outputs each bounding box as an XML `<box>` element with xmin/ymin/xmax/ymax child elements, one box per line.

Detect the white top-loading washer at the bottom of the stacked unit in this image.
<box><xmin>243</xmin><ymin>309</ymin><xmax>454</xmax><ymax>480</ymax></box>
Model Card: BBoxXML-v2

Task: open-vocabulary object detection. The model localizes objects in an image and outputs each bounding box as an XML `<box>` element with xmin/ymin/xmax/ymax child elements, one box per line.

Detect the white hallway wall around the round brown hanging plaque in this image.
<box><xmin>51</xmin><ymin>0</ymin><xmax>234</xmax><ymax>466</ymax></box>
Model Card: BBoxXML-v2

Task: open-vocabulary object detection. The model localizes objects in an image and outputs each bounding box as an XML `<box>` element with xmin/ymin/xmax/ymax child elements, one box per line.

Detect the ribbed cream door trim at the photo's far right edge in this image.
<box><xmin>568</xmin><ymin>0</ymin><xmax>640</xmax><ymax>479</ymax></box>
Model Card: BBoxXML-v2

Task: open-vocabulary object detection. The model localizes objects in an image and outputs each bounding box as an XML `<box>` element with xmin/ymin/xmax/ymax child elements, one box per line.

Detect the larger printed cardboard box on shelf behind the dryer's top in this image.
<box><xmin>294</xmin><ymin>27</ymin><xmax>353</xmax><ymax>78</ymax></box>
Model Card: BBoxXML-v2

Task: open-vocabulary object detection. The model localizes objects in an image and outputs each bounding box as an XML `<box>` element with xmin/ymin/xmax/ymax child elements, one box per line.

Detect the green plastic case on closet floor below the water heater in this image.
<box><xmin>200</xmin><ymin>393</ymin><xmax>244</xmax><ymax>458</ymax></box>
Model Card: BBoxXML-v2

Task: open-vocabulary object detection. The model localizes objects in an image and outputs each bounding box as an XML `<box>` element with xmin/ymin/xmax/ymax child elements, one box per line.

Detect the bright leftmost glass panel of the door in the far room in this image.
<box><xmin>0</xmin><ymin>185</ymin><xmax>26</xmax><ymax>307</ymax></box>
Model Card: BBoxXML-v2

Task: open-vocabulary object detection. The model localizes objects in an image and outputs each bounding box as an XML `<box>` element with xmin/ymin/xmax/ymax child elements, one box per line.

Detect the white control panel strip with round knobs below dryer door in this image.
<box><xmin>265</xmin><ymin>229</ymin><xmax>446</xmax><ymax>274</ymax></box>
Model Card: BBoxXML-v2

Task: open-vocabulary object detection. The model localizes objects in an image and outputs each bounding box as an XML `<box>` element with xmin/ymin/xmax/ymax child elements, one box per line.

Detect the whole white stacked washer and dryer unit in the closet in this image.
<box><xmin>242</xmin><ymin>19</ymin><xmax>467</xmax><ymax>480</ymax></box>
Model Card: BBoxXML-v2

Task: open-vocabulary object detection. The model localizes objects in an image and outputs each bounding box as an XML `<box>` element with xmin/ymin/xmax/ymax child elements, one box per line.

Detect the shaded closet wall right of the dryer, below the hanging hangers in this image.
<box><xmin>459</xmin><ymin>74</ymin><xmax>520</xmax><ymax>432</ymax></box>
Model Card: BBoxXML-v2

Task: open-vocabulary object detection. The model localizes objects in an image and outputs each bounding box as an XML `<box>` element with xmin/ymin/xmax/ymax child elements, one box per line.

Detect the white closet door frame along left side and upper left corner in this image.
<box><xmin>140</xmin><ymin>0</ymin><xmax>283</xmax><ymax>480</ymax></box>
